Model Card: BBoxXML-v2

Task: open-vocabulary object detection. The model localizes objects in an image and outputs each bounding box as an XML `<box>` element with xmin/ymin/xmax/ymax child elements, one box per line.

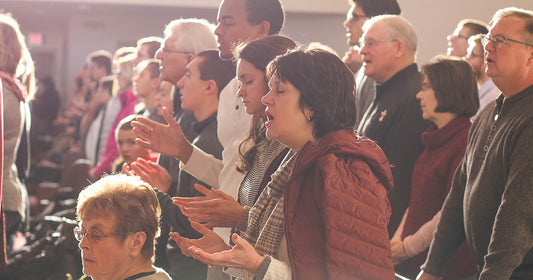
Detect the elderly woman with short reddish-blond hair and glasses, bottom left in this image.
<box><xmin>74</xmin><ymin>174</ymin><xmax>170</xmax><ymax>280</ymax></box>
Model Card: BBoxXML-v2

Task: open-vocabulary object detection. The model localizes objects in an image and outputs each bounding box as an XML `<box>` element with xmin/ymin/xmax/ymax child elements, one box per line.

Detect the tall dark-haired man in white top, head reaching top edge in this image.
<box><xmin>178</xmin><ymin>0</ymin><xmax>284</xmax><ymax>249</ymax></box>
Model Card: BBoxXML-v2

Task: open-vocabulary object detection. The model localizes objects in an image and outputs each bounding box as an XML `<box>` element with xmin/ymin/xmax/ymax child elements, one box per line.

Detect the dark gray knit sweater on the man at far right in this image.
<box><xmin>423</xmin><ymin>85</ymin><xmax>533</xmax><ymax>280</ymax></box>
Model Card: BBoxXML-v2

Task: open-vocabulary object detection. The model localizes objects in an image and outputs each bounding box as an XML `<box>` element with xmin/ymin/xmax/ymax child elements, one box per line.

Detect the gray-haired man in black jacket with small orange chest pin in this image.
<box><xmin>357</xmin><ymin>15</ymin><xmax>429</xmax><ymax>237</ymax></box>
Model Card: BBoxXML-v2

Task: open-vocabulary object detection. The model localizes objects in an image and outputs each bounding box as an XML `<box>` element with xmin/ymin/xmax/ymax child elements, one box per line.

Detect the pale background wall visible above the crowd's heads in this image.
<box><xmin>4</xmin><ymin>0</ymin><xmax>533</xmax><ymax>103</ymax></box>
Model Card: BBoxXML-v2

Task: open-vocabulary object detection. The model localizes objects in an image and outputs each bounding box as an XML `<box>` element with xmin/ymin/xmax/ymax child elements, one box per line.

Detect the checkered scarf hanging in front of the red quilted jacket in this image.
<box><xmin>242</xmin><ymin>151</ymin><xmax>296</xmax><ymax>258</ymax></box>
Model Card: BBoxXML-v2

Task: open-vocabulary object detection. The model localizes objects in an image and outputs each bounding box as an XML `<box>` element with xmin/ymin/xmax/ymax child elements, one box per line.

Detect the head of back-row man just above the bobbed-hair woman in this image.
<box><xmin>446</xmin><ymin>19</ymin><xmax>489</xmax><ymax>57</ymax></box>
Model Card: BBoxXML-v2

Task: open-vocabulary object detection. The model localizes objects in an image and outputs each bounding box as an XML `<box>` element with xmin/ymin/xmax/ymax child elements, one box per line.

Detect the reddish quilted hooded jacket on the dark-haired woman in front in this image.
<box><xmin>284</xmin><ymin>130</ymin><xmax>394</xmax><ymax>280</ymax></box>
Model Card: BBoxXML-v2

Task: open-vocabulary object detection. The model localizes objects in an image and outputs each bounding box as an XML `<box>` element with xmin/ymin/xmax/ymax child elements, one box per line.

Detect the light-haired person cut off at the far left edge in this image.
<box><xmin>0</xmin><ymin>10</ymin><xmax>35</xmax><ymax>253</ymax></box>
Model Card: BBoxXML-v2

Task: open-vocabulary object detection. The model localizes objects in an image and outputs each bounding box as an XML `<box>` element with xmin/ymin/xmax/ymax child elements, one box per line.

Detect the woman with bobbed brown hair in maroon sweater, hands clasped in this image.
<box><xmin>391</xmin><ymin>56</ymin><xmax>479</xmax><ymax>279</ymax></box>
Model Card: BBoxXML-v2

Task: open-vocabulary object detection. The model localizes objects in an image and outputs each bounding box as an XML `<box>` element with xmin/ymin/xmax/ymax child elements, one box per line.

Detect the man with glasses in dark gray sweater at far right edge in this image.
<box><xmin>418</xmin><ymin>8</ymin><xmax>533</xmax><ymax>280</ymax></box>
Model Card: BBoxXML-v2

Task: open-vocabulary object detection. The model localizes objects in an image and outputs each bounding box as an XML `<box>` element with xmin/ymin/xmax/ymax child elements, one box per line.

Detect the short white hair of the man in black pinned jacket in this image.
<box><xmin>363</xmin><ymin>15</ymin><xmax>418</xmax><ymax>58</ymax></box>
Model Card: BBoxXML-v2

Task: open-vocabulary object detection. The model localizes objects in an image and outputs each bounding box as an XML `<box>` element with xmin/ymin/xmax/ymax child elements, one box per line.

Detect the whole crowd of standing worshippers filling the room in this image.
<box><xmin>0</xmin><ymin>0</ymin><xmax>533</xmax><ymax>280</ymax></box>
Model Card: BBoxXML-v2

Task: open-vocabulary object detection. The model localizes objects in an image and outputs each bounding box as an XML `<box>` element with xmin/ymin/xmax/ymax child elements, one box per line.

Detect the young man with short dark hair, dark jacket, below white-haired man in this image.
<box><xmin>149</xmin><ymin>50</ymin><xmax>235</xmax><ymax>280</ymax></box>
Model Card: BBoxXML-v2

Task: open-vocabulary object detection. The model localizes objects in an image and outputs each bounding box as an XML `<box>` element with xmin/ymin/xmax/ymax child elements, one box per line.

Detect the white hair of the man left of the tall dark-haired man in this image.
<box><xmin>164</xmin><ymin>18</ymin><xmax>217</xmax><ymax>55</ymax></box>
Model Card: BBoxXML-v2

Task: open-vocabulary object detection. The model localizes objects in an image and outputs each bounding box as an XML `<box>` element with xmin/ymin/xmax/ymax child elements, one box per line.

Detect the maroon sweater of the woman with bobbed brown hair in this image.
<box><xmin>396</xmin><ymin>117</ymin><xmax>477</xmax><ymax>279</ymax></box>
